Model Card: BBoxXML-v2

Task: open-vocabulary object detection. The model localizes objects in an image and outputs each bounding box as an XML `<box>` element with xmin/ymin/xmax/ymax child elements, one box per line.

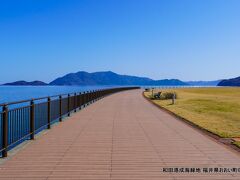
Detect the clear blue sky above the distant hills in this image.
<box><xmin>0</xmin><ymin>0</ymin><xmax>240</xmax><ymax>83</ymax></box>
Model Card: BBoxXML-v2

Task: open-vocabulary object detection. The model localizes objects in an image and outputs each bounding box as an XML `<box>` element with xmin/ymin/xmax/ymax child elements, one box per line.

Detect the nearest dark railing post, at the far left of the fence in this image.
<box><xmin>2</xmin><ymin>105</ymin><xmax>8</xmax><ymax>157</ymax></box>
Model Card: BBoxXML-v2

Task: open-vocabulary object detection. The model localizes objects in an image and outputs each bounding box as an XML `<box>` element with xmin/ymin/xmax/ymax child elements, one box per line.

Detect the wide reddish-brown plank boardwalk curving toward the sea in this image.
<box><xmin>0</xmin><ymin>90</ymin><xmax>240</xmax><ymax>180</ymax></box>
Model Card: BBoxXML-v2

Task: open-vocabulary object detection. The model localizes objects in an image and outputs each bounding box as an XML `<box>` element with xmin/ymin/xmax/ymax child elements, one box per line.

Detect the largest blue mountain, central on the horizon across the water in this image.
<box><xmin>50</xmin><ymin>71</ymin><xmax>188</xmax><ymax>86</ymax></box>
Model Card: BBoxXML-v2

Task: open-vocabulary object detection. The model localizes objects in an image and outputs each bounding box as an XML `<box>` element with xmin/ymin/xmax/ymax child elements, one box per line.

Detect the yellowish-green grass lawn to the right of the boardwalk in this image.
<box><xmin>144</xmin><ymin>88</ymin><xmax>240</xmax><ymax>139</ymax></box>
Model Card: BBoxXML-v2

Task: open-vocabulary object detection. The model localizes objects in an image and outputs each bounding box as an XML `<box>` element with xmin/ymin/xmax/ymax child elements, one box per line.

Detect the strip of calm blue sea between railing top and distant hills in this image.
<box><xmin>0</xmin><ymin>86</ymin><xmax>116</xmax><ymax>104</ymax></box>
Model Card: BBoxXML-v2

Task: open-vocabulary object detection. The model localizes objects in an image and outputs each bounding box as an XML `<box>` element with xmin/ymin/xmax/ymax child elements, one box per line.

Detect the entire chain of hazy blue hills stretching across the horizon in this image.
<box><xmin>2</xmin><ymin>71</ymin><xmax>240</xmax><ymax>87</ymax></box>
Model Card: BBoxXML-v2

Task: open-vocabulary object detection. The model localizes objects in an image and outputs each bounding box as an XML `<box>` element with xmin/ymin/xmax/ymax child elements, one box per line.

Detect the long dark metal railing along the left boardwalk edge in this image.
<box><xmin>0</xmin><ymin>87</ymin><xmax>139</xmax><ymax>157</ymax></box>
